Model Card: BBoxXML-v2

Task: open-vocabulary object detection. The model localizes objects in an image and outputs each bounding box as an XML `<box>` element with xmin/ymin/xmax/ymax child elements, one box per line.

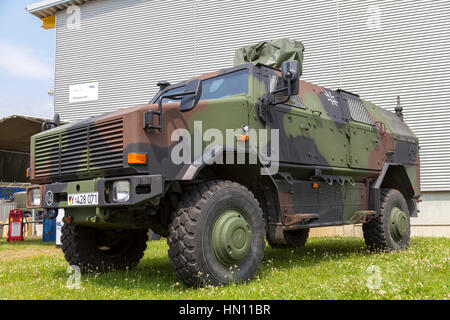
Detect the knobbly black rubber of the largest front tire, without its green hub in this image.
<box><xmin>167</xmin><ymin>181</ymin><xmax>265</xmax><ymax>287</ymax></box>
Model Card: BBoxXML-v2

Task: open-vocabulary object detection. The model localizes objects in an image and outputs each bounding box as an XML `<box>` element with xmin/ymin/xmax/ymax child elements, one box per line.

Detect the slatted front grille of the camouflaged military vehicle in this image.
<box><xmin>34</xmin><ymin>119</ymin><xmax>123</xmax><ymax>178</ymax></box>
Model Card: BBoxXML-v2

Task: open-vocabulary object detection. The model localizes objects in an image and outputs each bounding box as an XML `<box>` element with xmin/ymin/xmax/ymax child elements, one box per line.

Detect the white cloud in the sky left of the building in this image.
<box><xmin>0</xmin><ymin>40</ymin><xmax>53</xmax><ymax>79</ymax></box>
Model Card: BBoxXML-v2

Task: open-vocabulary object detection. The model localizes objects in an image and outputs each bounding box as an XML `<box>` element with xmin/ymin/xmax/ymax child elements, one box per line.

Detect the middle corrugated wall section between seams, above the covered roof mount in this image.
<box><xmin>195</xmin><ymin>0</ymin><xmax>339</xmax><ymax>87</ymax></box>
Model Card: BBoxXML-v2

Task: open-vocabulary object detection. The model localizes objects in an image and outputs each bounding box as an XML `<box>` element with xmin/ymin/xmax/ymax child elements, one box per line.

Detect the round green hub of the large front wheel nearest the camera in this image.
<box><xmin>211</xmin><ymin>210</ymin><xmax>251</xmax><ymax>266</ymax></box>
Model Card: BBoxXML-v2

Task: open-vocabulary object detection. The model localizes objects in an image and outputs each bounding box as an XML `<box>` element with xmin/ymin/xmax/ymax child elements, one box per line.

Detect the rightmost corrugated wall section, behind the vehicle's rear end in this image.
<box><xmin>339</xmin><ymin>0</ymin><xmax>450</xmax><ymax>191</ymax></box>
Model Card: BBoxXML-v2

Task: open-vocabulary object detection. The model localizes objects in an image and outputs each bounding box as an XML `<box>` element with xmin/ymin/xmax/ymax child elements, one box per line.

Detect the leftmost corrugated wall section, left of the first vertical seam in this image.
<box><xmin>55</xmin><ymin>0</ymin><xmax>194</xmax><ymax>121</ymax></box>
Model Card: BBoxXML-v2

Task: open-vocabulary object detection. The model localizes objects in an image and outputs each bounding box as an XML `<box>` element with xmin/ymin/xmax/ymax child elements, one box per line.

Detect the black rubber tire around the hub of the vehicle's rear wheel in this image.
<box><xmin>362</xmin><ymin>189</ymin><xmax>411</xmax><ymax>251</ymax></box>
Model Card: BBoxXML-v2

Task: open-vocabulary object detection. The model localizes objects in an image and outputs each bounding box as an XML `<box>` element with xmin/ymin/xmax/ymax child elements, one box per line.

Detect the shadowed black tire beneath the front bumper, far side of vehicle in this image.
<box><xmin>61</xmin><ymin>223</ymin><xmax>148</xmax><ymax>273</ymax></box>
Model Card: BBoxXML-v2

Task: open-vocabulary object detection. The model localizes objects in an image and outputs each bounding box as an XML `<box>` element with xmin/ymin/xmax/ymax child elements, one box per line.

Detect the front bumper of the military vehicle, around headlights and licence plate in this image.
<box><xmin>27</xmin><ymin>175</ymin><xmax>164</xmax><ymax>209</ymax></box>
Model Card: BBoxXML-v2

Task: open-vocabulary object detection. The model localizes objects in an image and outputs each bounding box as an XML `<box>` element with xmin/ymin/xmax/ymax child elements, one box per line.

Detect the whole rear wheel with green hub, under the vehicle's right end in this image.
<box><xmin>363</xmin><ymin>189</ymin><xmax>411</xmax><ymax>251</ymax></box>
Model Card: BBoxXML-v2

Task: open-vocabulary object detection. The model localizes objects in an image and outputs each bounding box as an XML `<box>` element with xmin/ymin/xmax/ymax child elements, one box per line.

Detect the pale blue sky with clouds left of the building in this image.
<box><xmin>0</xmin><ymin>0</ymin><xmax>55</xmax><ymax>118</ymax></box>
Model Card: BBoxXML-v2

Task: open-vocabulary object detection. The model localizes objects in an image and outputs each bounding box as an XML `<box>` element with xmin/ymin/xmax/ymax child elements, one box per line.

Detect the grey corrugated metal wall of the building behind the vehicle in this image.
<box><xmin>55</xmin><ymin>0</ymin><xmax>450</xmax><ymax>191</ymax></box>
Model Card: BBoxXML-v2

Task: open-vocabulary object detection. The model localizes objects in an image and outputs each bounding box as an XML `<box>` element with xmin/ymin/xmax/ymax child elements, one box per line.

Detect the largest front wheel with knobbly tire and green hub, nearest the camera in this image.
<box><xmin>167</xmin><ymin>181</ymin><xmax>265</xmax><ymax>287</ymax></box>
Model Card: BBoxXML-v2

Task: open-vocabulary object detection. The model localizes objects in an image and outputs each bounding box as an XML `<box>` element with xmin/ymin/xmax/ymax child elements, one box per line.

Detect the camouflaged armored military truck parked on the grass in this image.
<box><xmin>27</xmin><ymin>39</ymin><xmax>420</xmax><ymax>286</ymax></box>
